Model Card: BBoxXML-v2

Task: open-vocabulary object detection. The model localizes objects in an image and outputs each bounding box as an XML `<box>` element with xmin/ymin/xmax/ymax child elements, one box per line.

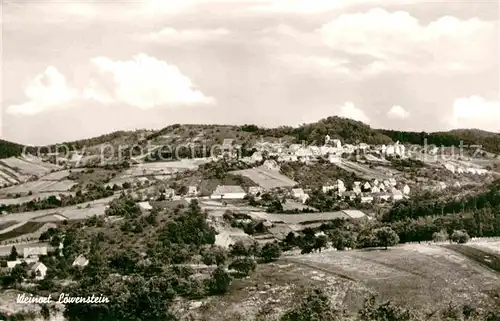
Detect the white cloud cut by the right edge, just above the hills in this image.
<box><xmin>449</xmin><ymin>96</ymin><xmax>500</xmax><ymax>132</ymax></box>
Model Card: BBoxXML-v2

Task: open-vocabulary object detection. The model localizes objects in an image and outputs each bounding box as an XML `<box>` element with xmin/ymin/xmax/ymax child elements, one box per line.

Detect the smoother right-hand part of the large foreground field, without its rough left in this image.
<box><xmin>289</xmin><ymin>245</ymin><xmax>500</xmax><ymax>310</ymax></box>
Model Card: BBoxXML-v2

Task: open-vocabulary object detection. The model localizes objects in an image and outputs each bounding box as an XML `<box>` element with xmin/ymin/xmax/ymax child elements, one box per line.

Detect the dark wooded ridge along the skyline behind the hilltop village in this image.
<box><xmin>0</xmin><ymin>116</ymin><xmax>500</xmax><ymax>158</ymax></box>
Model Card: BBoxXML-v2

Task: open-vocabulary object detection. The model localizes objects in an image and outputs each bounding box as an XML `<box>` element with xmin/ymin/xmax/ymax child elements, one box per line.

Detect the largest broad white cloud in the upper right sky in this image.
<box><xmin>318</xmin><ymin>8</ymin><xmax>496</xmax><ymax>75</ymax></box>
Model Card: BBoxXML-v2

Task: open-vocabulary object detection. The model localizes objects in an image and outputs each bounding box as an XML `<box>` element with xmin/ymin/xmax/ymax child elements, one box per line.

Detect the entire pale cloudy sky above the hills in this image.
<box><xmin>0</xmin><ymin>0</ymin><xmax>500</xmax><ymax>144</ymax></box>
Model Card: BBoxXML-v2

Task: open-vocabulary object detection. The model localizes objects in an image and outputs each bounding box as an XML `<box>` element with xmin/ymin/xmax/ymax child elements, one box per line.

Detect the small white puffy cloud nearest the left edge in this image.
<box><xmin>6</xmin><ymin>66</ymin><xmax>78</xmax><ymax>115</ymax></box>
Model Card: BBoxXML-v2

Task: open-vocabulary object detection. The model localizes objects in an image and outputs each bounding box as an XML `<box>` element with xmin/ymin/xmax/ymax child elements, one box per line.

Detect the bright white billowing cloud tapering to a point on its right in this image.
<box><xmin>92</xmin><ymin>54</ymin><xmax>215</xmax><ymax>109</ymax></box>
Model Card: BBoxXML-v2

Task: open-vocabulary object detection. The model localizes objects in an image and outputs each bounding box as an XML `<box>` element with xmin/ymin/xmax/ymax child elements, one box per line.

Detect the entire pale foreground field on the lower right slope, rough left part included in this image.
<box><xmin>182</xmin><ymin>245</ymin><xmax>500</xmax><ymax>321</ymax></box>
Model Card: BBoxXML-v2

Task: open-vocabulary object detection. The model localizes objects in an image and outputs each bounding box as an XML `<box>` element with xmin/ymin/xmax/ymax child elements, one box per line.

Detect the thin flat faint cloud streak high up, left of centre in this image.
<box><xmin>150</xmin><ymin>28</ymin><xmax>229</xmax><ymax>42</ymax></box>
